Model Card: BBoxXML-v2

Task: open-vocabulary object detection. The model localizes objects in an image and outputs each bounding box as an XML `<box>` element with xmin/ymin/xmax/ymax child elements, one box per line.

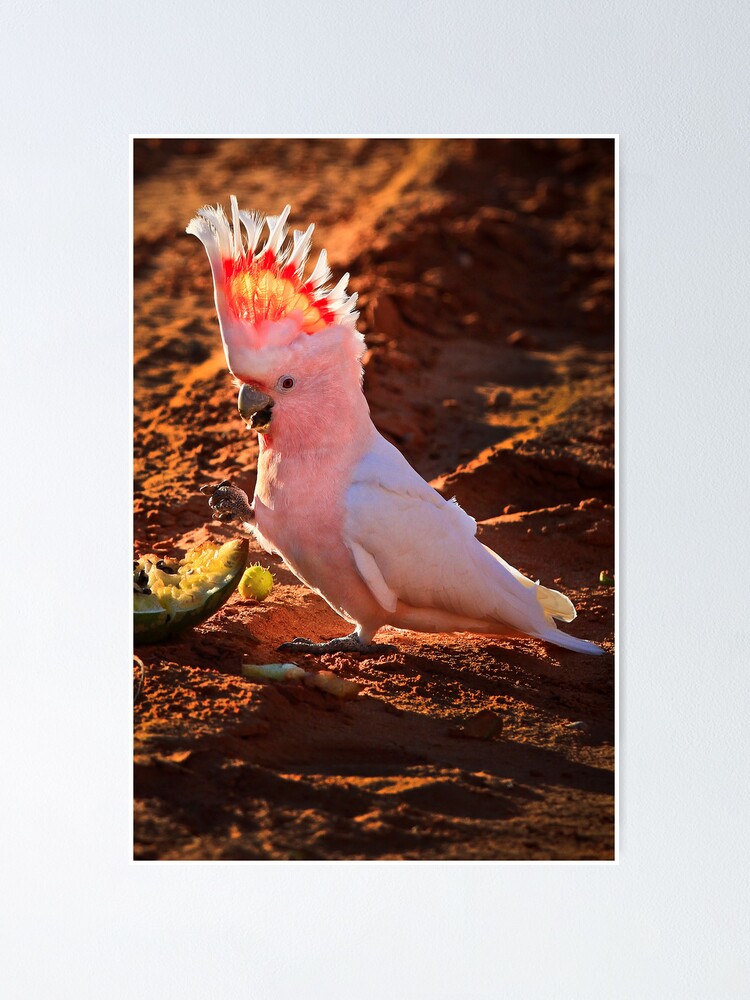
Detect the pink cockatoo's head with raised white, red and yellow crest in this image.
<box><xmin>187</xmin><ymin>196</ymin><xmax>366</xmax><ymax>444</ymax></box>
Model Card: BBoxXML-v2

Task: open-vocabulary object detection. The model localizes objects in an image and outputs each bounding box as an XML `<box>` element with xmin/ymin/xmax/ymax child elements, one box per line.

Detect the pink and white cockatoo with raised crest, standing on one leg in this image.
<box><xmin>186</xmin><ymin>196</ymin><xmax>604</xmax><ymax>654</ymax></box>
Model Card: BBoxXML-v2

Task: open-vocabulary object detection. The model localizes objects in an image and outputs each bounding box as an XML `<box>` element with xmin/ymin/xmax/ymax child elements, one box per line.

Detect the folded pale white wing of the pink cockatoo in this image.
<box><xmin>344</xmin><ymin>438</ymin><xmax>545</xmax><ymax>631</ymax></box>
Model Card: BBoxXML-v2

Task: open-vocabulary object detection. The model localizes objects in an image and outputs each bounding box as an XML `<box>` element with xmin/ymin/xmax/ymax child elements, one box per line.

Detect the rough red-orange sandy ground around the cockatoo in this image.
<box><xmin>134</xmin><ymin>139</ymin><xmax>614</xmax><ymax>860</ymax></box>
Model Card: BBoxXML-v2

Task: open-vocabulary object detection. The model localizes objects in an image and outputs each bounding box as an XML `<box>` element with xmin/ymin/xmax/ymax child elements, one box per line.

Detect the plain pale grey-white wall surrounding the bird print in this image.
<box><xmin>0</xmin><ymin>0</ymin><xmax>750</xmax><ymax>1000</ymax></box>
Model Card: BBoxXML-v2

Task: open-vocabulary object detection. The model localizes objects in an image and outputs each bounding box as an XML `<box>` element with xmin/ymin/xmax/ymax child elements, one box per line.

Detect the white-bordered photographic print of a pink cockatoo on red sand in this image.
<box><xmin>132</xmin><ymin>136</ymin><xmax>617</xmax><ymax>862</ymax></box>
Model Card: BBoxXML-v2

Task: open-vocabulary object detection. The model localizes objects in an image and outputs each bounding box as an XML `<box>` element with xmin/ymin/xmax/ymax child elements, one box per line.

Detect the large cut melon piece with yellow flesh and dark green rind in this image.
<box><xmin>133</xmin><ymin>538</ymin><xmax>248</xmax><ymax>646</ymax></box>
